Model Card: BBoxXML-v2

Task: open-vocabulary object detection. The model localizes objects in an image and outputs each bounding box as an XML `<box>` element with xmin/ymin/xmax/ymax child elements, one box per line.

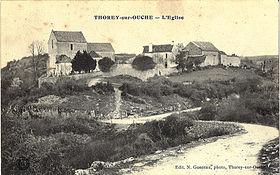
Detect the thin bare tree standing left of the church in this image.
<box><xmin>28</xmin><ymin>41</ymin><xmax>44</xmax><ymax>84</ymax></box>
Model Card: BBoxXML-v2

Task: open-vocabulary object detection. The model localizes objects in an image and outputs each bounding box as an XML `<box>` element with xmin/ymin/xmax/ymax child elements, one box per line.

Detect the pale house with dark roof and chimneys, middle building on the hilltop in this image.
<box><xmin>142</xmin><ymin>43</ymin><xmax>176</xmax><ymax>68</ymax></box>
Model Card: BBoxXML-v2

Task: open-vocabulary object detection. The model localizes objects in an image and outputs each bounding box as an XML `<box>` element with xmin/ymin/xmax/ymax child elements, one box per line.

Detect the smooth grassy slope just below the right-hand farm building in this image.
<box><xmin>168</xmin><ymin>68</ymin><xmax>260</xmax><ymax>82</ymax></box>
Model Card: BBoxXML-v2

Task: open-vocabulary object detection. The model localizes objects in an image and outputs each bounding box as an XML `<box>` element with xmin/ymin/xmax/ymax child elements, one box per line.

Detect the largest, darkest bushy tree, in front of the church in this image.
<box><xmin>72</xmin><ymin>51</ymin><xmax>96</xmax><ymax>72</ymax></box>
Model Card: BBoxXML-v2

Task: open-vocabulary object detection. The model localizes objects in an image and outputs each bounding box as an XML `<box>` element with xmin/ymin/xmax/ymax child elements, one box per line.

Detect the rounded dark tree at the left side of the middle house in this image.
<box><xmin>132</xmin><ymin>55</ymin><xmax>156</xmax><ymax>71</ymax></box>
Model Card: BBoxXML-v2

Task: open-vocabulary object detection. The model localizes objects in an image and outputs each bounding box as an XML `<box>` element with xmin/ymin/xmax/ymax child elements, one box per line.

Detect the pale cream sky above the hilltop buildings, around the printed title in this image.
<box><xmin>1</xmin><ymin>0</ymin><xmax>278</xmax><ymax>67</ymax></box>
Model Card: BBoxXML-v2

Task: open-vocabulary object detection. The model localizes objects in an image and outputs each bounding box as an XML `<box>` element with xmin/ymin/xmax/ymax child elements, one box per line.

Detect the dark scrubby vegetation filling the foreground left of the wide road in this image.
<box><xmin>1</xmin><ymin>109</ymin><xmax>243</xmax><ymax>174</ymax></box>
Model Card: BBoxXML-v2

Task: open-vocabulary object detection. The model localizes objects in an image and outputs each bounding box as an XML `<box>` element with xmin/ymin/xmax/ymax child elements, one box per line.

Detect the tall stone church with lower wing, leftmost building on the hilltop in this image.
<box><xmin>47</xmin><ymin>30</ymin><xmax>115</xmax><ymax>76</ymax></box>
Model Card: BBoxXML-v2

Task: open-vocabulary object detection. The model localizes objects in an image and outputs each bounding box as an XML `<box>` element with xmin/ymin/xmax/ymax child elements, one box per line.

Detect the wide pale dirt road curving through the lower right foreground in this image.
<box><xmin>129</xmin><ymin>124</ymin><xmax>279</xmax><ymax>175</ymax></box>
